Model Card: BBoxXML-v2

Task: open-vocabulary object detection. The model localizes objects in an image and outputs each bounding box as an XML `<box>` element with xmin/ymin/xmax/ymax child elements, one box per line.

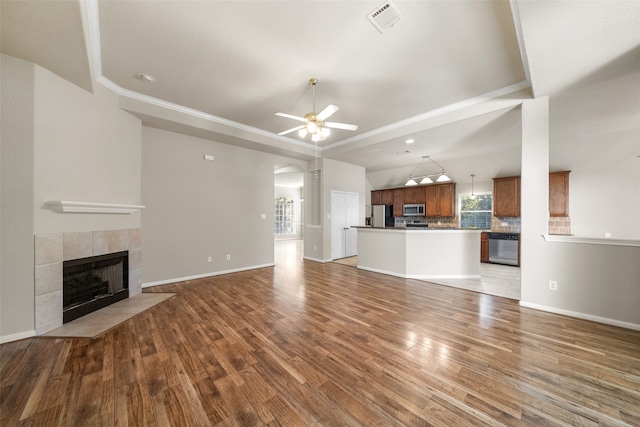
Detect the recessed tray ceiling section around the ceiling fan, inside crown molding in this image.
<box><xmin>99</xmin><ymin>1</ymin><xmax>525</xmax><ymax>139</ymax></box>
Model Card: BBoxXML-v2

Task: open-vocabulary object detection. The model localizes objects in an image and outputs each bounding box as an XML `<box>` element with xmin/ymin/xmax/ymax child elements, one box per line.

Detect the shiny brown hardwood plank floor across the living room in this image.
<box><xmin>0</xmin><ymin>244</ymin><xmax>640</xmax><ymax>426</ymax></box>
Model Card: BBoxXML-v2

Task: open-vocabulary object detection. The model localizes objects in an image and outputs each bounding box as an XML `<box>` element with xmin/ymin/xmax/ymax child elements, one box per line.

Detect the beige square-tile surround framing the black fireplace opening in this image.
<box><xmin>34</xmin><ymin>228</ymin><xmax>142</xmax><ymax>335</ymax></box>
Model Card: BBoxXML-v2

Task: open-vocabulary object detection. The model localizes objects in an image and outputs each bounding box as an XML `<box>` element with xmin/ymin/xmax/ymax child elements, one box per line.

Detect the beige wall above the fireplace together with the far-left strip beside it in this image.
<box><xmin>0</xmin><ymin>55</ymin><xmax>141</xmax><ymax>340</ymax></box>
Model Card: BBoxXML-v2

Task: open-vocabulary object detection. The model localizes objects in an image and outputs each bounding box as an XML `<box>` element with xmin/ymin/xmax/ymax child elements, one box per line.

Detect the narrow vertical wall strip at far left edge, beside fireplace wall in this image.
<box><xmin>0</xmin><ymin>55</ymin><xmax>35</xmax><ymax>342</ymax></box>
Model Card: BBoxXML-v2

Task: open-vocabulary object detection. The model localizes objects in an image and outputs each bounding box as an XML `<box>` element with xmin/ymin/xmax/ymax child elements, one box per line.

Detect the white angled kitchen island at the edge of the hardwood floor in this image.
<box><xmin>354</xmin><ymin>227</ymin><xmax>480</xmax><ymax>280</ymax></box>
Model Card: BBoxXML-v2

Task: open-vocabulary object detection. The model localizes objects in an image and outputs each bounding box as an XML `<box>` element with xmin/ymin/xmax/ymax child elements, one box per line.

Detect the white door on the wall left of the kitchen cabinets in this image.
<box><xmin>331</xmin><ymin>191</ymin><xmax>359</xmax><ymax>259</ymax></box>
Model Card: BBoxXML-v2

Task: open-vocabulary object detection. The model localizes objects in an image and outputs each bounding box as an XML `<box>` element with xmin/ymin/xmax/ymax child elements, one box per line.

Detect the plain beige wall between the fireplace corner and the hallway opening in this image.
<box><xmin>142</xmin><ymin>127</ymin><xmax>305</xmax><ymax>286</ymax></box>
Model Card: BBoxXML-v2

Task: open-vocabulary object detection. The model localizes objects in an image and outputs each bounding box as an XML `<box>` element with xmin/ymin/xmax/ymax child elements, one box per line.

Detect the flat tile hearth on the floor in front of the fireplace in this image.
<box><xmin>41</xmin><ymin>293</ymin><xmax>175</xmax><ymax>338</ymax></box>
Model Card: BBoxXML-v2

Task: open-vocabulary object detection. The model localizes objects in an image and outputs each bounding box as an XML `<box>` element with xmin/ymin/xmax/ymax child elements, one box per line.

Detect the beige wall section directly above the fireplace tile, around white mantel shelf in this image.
<box><xmin>33</xmin><ymin>67</ymin><xmax>142</xmax><ymax>234</ymax></box>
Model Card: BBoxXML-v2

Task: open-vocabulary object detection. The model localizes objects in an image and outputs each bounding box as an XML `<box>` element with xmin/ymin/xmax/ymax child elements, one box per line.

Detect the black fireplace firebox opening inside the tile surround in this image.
<box><xmin>62</xmin><ymin>251</ymin><xmax>129</xmax><ymax>323</ymax></box>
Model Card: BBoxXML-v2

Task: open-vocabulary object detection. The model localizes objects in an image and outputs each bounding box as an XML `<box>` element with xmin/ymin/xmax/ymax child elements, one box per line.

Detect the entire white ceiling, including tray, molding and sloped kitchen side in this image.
<box><xmin>0</xmin><ymin>0</ymin><xmax>640</xmax><ymax>187</ymax></box>
